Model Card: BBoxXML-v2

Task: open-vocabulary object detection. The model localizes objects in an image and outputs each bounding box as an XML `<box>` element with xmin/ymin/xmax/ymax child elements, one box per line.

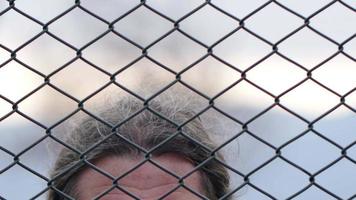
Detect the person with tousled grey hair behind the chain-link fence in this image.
<box><xmin>48</xmin><ymin>95</ymin><xmax>229</xmax><ymax>200</ymax></box>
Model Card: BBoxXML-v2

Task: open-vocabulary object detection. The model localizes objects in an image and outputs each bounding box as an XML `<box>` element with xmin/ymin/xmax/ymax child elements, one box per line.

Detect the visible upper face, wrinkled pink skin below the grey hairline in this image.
<box><xmin>73</xmin><ymin>154</ymin><xmax>204</xmax><ymax>200</ymax></box>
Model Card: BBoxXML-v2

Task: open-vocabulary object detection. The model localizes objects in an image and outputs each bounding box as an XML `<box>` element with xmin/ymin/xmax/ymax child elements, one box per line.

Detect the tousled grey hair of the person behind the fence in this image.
<box><xmin>47</xmin><ymin>94</ymin><xmax>230</xmax><ymax>200</ymax></box>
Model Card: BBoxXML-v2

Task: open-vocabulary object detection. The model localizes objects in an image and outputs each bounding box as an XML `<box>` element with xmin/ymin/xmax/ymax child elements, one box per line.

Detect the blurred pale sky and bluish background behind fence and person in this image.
<box><xmin>0</xmin><ymin>0</ymin><xmax>356</xmax><ymax>200</ymax></box>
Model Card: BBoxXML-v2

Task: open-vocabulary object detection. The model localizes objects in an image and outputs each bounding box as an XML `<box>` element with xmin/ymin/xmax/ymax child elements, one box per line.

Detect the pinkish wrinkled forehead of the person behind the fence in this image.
<box><xmin>73</xmin><ymin>153</ymin><xmax>204</xmax><ymax>198</ymax></box>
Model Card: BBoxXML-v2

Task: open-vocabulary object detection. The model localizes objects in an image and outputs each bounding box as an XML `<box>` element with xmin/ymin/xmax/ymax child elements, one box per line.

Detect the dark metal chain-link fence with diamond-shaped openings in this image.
<box><xmin>0</xmin><ymin>0</ymin><xmax>356</xmax><ymax>199</ymax></box>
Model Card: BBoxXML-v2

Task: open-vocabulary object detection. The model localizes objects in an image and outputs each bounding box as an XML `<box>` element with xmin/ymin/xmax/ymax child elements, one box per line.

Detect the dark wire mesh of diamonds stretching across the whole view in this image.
<box><xmin>0</xmin><ymin>0</ymin><xmax>356</xmax><ymax>199</ymax></box>
